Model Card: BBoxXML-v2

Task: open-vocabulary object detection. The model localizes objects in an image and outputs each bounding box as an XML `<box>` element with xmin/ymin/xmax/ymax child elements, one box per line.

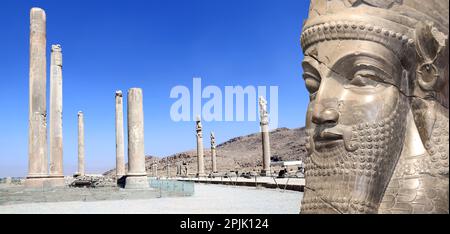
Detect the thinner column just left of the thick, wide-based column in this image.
<box><xmin>116</xmin><ymin>91</ymin><xmax>125</xmax><ymax>179</ymax></box>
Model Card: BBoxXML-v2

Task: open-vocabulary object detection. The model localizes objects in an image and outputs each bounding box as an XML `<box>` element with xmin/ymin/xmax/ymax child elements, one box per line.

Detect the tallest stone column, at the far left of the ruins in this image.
<box><xmin>25</xmin><ymin>8</ymin><xmax>48</xmax><ymax>187</ymax></box>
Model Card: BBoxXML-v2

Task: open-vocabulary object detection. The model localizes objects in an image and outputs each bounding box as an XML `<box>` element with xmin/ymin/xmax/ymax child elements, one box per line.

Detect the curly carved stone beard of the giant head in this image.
<box><xmin>301</xmin><ymin>97</ymin><xmax>407</xmax><ymax>213</ymax></box>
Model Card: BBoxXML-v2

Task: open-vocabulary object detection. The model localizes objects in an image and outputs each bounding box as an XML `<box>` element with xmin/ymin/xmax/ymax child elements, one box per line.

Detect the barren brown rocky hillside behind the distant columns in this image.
<box><xmin>104</xmin><ymin>128</ymin><xmax>306</xmax><ymax>176</ymax></box>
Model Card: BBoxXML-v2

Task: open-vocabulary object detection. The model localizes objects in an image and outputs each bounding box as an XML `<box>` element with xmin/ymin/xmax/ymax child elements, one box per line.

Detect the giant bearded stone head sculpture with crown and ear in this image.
<box><xmin>301</xmin><ymin>0</ymin><xmax>449</xmax><ymax>213</ymax></box>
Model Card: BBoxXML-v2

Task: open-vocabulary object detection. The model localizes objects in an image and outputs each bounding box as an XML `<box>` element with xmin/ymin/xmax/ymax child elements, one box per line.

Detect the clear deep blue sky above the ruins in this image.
<box><xmin>0</xmin><ymin>0</ymin><xmax>309</xmax><ymax>177</ymax></box>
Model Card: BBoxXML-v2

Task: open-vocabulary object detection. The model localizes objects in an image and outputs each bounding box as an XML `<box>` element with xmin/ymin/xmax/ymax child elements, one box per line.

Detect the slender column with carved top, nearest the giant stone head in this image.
<box><xmin>259</xmin><ymin>96</ymin><xmax>270</xmax><ymax>176</ymax></box>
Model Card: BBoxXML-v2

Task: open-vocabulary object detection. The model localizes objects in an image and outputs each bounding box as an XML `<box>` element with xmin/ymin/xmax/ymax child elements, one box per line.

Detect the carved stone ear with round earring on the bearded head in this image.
<box><xmin>416</xmin><ymin>22</ymin><xmax>447</xmax><ymax>91</ymax></box>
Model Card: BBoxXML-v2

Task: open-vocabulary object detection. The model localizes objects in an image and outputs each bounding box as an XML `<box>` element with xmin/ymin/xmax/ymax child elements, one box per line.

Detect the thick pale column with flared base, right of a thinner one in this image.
<box><xmin>125</xmin><ymin>88</ymin><xmax>149</xmax><ymax>189</ymax></box>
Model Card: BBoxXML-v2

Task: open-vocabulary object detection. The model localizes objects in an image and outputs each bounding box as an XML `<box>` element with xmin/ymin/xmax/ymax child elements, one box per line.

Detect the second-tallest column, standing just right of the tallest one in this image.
<box><xmin>49</xmin><ymin>45</ymin><xmax>64</xmax><ymax>186</ymax></box>
